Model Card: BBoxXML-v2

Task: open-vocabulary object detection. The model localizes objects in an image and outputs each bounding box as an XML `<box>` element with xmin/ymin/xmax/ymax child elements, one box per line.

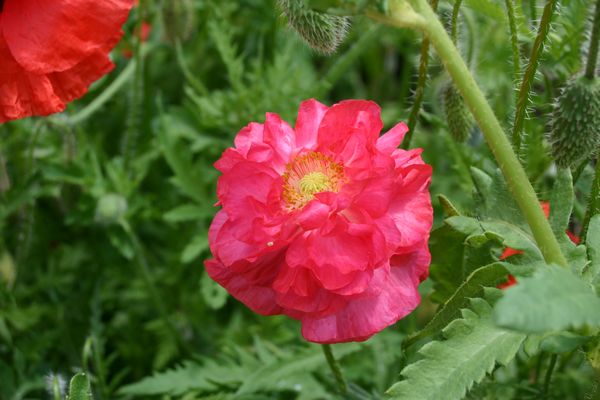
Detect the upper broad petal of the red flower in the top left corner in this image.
<box><xmin>2</xmin><ymin>0</ymin><xmax>134</xmax><ymax>74</ymax></box>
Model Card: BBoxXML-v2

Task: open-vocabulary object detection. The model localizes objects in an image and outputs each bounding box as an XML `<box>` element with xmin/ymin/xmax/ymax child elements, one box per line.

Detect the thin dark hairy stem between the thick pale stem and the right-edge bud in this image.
<box><xmin>512</xmin><ymin>0</ymin><xmax>557</xmax><ymax>154</ymax></box>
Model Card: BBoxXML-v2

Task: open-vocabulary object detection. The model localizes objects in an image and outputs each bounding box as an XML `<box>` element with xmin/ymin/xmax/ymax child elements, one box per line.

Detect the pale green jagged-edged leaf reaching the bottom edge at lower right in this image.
<box><xmin>387</xmin><ymin>299</ymin><xmax>525</xmax><ymax>400</ymax></box>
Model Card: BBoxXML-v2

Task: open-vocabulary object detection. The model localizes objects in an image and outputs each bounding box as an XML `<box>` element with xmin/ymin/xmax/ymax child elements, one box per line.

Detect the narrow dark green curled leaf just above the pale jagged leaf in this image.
<box><xmin>403</xmin><ymin>263</ymin><xmax>508</xmax><ymax>347</ymax></box>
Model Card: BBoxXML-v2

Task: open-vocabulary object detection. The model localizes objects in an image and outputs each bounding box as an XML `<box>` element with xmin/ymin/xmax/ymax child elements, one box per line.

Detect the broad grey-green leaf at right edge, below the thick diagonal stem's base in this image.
<box><xmin>494</xmin><ymin>266</ymin><xmax>600</xmax><ymax>333</ymax></box>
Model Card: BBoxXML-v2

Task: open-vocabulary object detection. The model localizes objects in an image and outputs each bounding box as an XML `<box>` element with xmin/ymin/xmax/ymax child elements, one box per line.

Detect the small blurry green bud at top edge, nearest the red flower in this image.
<box><xmin>161</xmin><ymin>0</ymin><xmax>195</xmax><ymax>44</ymax></box>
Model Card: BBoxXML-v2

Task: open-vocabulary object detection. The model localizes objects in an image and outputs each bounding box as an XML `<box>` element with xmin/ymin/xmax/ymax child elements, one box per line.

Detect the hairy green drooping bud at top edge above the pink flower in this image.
<box><xmin>279</xmin><ymin>0</ymin><xmax>349</xmax><ymax>54</ymax></box>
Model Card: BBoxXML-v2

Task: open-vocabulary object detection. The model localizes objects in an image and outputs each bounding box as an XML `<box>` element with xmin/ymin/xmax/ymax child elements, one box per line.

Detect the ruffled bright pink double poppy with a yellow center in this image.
<box><xmin>205</xmin><ymin>100</ymin><xmax>433</xmax><ymax>343</ymax></box>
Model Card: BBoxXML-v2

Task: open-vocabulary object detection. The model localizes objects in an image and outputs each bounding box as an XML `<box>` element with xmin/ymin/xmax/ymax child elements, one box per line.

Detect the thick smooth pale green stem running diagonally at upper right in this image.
<box><xmin>379</xmin><ymin>0</ymin><xmax>567</xmax><ymax>267</ymax></box>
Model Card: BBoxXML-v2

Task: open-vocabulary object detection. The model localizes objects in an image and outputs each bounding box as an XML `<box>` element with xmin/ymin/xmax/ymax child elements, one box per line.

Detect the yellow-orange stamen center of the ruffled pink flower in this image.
<box><xmin>283</xmin><ymin>151</ymin><xmax>345</xmax><ymax>211</ymax></box>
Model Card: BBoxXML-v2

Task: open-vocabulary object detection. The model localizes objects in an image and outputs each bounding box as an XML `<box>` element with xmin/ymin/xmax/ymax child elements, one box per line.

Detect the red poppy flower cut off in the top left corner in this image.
<box><xmin>0</xmin><ymin>0</ymin><xmax>134</xmax><ymax>123</ymax></box>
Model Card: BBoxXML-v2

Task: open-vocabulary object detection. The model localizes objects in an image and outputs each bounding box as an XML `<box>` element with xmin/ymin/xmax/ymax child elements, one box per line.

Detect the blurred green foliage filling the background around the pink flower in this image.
<box><xmin>0</xmin><ymin>0</ymin><xmax>593</xmax><ymax>400</ymax></box>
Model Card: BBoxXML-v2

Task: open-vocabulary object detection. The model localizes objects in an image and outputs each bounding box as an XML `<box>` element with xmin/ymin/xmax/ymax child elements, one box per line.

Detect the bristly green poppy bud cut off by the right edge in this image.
<box><xmin>548</xmin><ymin>76</ymin><xmax>600</xmax><ymax>167</ymax></box>
